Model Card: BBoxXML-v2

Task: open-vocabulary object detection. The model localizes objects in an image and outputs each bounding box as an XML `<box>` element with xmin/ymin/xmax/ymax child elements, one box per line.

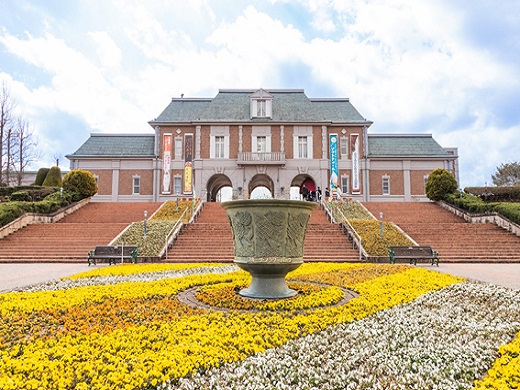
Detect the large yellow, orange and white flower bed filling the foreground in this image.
<box><xmin>0</xmin><ymin>263</ymin><xmax>520</xmax><ymax>389</ymax></box>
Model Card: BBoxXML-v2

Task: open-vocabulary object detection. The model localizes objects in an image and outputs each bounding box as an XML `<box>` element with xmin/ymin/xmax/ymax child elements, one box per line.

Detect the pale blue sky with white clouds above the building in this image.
<box><xmin>0</xmin><ymin>0</ymin><xmax>520</xmax><ymax>186</ymax></box>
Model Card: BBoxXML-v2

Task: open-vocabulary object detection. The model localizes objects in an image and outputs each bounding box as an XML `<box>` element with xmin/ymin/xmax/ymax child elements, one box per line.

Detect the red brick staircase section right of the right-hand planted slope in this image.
<box><xmin>364</xmin><ymin>202</ymin><xmax>520</xmax><ymax>263</ymax></box>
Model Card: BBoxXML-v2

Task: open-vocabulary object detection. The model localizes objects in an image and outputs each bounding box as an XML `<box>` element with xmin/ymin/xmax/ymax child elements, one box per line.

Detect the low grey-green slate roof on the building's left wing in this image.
<box><xmin>66</xmin><ymin>134</ymin><xmax>155</xmax><ymax>158</ymax></box>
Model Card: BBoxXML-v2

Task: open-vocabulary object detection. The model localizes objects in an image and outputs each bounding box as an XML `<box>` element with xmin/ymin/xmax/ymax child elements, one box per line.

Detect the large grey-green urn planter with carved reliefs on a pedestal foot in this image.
<box><xmin>222</xmin><ymin>199</ymin><xmax>316</xmax><ymax>299</ymax></box>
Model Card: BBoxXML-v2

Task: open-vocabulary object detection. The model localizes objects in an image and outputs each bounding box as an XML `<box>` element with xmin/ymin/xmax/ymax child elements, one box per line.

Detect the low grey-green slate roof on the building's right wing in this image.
<box><xmin>368</xmin><ymin>134</ymin><xmax>453</xmax><ymax>158</ymax></box>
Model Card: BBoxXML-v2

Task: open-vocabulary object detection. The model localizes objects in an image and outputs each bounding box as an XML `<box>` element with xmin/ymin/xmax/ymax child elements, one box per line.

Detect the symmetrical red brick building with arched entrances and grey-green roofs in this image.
<box><xmin>67</xmin><ymin>89</ymin><xmax>458</xmax><ymax>201</ymax></box>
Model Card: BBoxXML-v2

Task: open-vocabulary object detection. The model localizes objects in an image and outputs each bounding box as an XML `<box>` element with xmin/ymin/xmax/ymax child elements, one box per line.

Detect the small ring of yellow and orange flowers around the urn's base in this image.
<box><xmin>195</xmin><ymin>282</ymin><xmax>352</xmax><ymax>311</ymax></box>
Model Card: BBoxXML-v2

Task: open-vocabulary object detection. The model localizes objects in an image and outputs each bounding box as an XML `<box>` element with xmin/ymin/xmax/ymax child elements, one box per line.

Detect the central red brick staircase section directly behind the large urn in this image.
<box><xmin>167</xmin><ymin>202</ymin><xmax>359</xmax><ymax>262</ymax></box>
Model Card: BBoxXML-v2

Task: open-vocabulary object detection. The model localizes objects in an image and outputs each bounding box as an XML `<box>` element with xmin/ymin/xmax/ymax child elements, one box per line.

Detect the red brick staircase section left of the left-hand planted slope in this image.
<box><xmin>0</xmin><ymin>202</ymin><xmax>161</xmax><ymax>263</ymax></box>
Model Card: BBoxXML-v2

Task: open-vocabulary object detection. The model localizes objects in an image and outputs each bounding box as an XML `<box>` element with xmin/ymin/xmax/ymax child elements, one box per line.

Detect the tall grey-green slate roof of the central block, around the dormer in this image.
<box><xmin>150</xmin><ymin>89</ymin><xmax>370</xmax><ymax>126</ymax></box>
